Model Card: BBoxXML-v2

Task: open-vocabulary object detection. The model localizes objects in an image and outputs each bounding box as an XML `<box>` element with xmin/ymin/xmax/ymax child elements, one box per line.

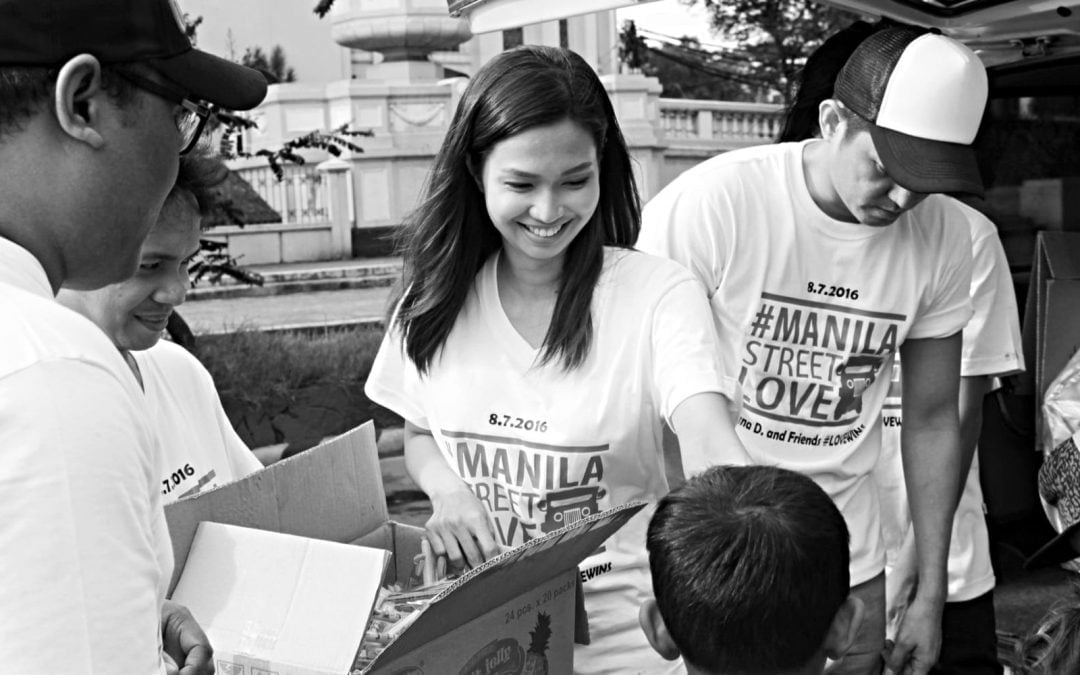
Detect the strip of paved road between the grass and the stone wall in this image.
<box><xmin>177</xmin><ymin>286</ymin><xmax>391</xmax><ymax>335</ymax></box>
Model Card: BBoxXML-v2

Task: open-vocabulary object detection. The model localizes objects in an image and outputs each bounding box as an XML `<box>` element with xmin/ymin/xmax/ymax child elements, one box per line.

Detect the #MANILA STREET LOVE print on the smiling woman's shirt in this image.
<box><xmin>441</xmin><ymin>430</ymin><xmax>612</xmax><ymax>546</ymax></box>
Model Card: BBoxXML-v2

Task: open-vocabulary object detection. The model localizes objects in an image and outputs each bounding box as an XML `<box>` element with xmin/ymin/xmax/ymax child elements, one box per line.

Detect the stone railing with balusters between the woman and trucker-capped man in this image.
<box><xmin>660</xmin><ymin>98</ymin><xmax>784</xmax><ymax>150</ymax></box>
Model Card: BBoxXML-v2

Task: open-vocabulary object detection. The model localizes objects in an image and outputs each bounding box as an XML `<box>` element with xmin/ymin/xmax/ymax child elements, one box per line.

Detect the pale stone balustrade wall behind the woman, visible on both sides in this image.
<box><xmin>221</xmin><ymin>60</ymin><xmax>782</xmax><ymax>264</ymax></box>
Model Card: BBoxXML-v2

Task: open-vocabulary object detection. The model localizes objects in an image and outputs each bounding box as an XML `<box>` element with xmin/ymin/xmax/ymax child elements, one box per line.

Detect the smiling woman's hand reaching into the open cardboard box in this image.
<box><xmin>427</xmin><ymin>480</ymin><xmax>499</xmax><ymax>568</ymax></box>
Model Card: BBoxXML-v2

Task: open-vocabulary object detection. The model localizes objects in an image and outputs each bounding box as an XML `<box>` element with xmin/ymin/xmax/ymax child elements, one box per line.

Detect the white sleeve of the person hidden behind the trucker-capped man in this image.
<box><xmin>960</xmin><ymin>212</ymin><xmax>1024</xmax><ymax>377</ymax></box>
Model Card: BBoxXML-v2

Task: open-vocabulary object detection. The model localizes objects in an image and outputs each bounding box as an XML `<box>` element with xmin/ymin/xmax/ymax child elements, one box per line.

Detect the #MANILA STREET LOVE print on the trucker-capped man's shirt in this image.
<box><xmin>739</xmin><ymin>293</ymin><xmax>906</xmax><ymax>446</ymax></box>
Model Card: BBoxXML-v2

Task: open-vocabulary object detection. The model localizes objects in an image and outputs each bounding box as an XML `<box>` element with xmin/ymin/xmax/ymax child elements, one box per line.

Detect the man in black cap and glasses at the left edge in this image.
<box><xmin>0</xmin><ymin>0</ymin><xmax>266</xmax><ymax>673</ymax></box>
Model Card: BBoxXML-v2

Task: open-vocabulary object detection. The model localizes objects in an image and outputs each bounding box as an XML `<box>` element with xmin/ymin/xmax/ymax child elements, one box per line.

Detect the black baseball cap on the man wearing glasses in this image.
<box><xmin>0</xmin><ymin>0</ymin><xmax>267</xmax><ymax>110</ymax></box>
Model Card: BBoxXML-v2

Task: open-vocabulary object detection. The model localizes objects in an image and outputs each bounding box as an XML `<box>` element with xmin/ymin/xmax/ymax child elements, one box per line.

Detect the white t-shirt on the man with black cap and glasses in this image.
<box><xmin>0</xmin><ymin>239</ymin><xmax>173</xmax><ymax>674</ymax></box>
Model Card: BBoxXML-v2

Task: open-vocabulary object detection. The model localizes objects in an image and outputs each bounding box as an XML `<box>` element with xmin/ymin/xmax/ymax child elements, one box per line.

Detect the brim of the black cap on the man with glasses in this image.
<box><xmin>150</xmin><ymin>49</ymin><xmax>267</xmax><ymax>110</ymax></box>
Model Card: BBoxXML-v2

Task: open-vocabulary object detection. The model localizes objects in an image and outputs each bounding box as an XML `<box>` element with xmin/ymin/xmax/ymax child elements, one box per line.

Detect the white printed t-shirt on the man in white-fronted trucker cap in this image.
<box><xmin>638</xmin><ymin>144</ymin><xmax>971</xmax><ymax>585</ymax></box>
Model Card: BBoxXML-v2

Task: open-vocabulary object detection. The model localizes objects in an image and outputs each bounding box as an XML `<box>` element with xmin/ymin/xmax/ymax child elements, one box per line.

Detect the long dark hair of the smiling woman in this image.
<box><xmin>388</xmin><ymin>45</ymin><xmax>640</xmax><ymax>373</ymax></box>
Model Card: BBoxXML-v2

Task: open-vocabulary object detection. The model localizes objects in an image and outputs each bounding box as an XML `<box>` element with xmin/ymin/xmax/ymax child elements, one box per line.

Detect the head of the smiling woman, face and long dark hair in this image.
<box><xmin>396</xmin><ymin>45</ymin><xmax>640</xmax><ymax>372</ymax></box>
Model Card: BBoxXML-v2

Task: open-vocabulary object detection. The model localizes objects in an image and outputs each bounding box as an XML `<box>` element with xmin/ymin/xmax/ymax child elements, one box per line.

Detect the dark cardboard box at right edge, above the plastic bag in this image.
<box><xmin>1023</xmin><ymin>231</ymin><xmax>1080</xmax><ymax>434</ymax></box>
